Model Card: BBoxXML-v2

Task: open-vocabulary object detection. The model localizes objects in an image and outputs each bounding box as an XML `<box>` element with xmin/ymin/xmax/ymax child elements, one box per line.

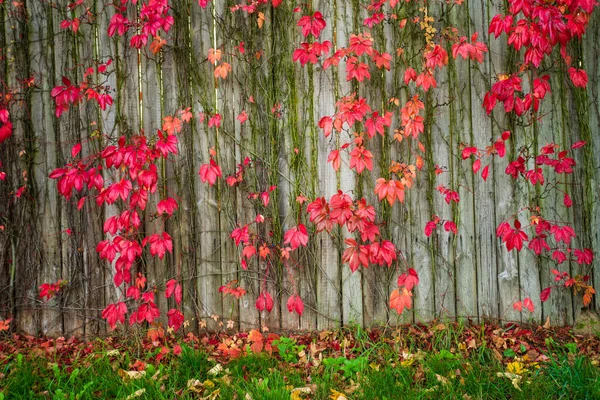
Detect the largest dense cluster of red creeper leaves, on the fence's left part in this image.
<box><xmin>49</xmin><ymin>110</ymin><xmax>190</xmax><ymax>330</ymax></box>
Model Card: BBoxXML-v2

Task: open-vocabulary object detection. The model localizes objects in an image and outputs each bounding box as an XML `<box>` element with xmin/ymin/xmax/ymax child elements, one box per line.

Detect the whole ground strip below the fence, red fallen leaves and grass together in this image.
<box><xmin>0</xmin><ymin>323</ymin><xmax>600</xmax><ymax>400</ymax></box>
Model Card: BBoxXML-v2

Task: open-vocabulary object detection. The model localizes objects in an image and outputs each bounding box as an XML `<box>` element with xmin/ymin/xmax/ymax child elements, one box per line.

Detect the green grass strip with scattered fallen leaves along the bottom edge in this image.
<box><xmin>0</xmin><ymin>326</ymin><xmax>600</xmax><ymax>400</ymax></box>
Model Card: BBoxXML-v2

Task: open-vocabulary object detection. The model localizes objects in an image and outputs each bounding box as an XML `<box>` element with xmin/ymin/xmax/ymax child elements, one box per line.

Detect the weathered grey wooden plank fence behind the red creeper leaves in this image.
<box><xmin>0</xmin><ymin>0</ymin><xmax>600</xmax><ymax>335</ymax></box>
